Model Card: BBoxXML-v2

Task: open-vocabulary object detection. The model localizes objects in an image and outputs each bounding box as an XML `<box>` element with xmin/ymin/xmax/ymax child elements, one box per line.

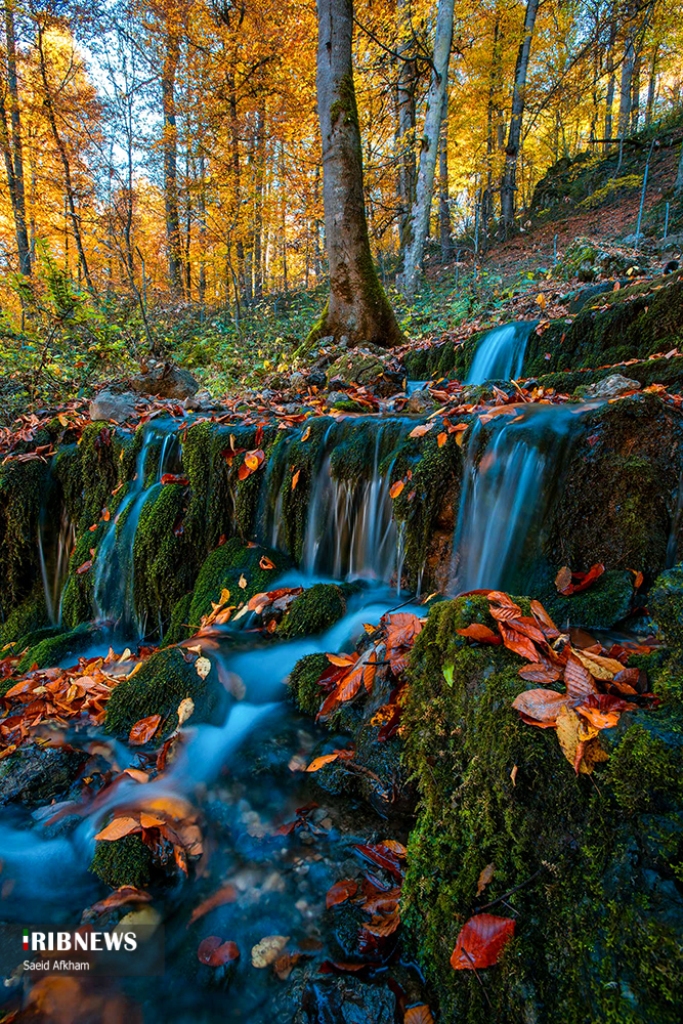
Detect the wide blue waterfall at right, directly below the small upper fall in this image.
<box><xmin>452</xmin><ymin>404</ymin><xmax>591</xmax><ymax>593</ymax></box>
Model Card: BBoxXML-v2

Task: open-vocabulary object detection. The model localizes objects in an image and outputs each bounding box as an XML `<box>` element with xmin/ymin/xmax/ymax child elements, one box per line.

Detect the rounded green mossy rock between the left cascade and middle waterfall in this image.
<box><xmin>189</xmin><ymin>537</ymin><xmax>293</xmax><ymax>627</ymax></box>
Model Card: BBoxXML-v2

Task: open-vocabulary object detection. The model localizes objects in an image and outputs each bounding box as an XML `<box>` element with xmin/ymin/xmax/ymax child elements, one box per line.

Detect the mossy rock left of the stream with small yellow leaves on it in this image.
<box><xmin>104</xmin><ymin>647</ymin><xmax>228</xmax><ymax>738</ymax></box>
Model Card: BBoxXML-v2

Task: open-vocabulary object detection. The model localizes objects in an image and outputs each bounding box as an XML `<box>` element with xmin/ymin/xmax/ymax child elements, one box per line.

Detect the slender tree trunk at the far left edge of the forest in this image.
<box><xmin>2</xmin><ymin>0</ymin><xmax>31</xmax><ymax>276</ymax></box>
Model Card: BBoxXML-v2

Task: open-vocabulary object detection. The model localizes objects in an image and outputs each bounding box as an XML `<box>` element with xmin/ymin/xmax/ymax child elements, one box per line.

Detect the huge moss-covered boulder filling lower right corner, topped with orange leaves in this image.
<box><xmin>401</xmin><ymin>598</ymin><xmax>683</xmax><ymax>1024</ymax></box>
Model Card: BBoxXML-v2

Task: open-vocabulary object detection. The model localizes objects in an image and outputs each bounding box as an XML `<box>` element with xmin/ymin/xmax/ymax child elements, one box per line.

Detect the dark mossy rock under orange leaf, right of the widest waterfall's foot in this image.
<box><xmin>542</xmin><ymin>569</ymin><xmax>634</xmax><ymax>630</ymax></box>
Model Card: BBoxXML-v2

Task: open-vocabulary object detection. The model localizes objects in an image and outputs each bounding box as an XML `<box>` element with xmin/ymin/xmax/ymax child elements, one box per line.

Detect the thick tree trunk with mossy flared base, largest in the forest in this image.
<box><xmin>309</xmin><ymin>0</ymin><xmax>403</xmax><ymax>347</ymax></box>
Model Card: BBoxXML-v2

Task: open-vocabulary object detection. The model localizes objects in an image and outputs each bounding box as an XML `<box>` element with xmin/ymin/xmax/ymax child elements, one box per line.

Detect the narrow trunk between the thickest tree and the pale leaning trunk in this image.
<box><xmin>396</xmin><ymin>0</ymin><xmax>418</xmax><ymax>265</ymax></box>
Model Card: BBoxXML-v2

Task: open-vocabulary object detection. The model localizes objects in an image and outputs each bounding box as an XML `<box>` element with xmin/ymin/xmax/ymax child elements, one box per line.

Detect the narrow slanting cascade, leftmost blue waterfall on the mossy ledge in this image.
<box><xmin>93</xmin><ymin>420</ymin><xmax>180</xmax><ymax>634</ymax></box>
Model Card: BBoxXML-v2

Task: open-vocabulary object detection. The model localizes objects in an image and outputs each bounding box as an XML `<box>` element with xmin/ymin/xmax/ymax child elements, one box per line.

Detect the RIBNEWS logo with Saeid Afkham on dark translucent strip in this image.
<box><xmin>0</xmin><ymin>922</ymin><xmax>164</xmax><ymax>977</ymax></box>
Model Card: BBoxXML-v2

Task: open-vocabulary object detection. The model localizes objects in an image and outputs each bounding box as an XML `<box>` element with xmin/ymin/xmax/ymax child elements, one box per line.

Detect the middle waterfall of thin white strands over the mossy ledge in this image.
<box><xmin>265</xmin><ymin>421</ymin><xmax>405</xmax><ymax>587</ymax></box>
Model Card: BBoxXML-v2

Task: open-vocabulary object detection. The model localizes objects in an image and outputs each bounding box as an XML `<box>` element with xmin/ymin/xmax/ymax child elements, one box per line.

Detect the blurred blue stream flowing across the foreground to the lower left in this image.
<box><xmin>0</xmin><ymin>575</ymin><xmax>428</xmax><ymax>1024</ymax></box>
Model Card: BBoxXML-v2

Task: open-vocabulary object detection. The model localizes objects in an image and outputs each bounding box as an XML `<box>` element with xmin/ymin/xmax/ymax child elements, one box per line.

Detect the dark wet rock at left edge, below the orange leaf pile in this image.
<box><xmin>0</xmin><ymin>743</ymin><xmax>88</xmax><ymax>808</ymax></box>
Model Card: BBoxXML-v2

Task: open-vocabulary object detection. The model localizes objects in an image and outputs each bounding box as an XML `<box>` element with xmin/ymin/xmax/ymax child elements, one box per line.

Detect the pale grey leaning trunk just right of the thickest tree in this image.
<box><xmin>397</xmin><ymin>0</ymin><xmax>454</xmax><ymax>298</ymax></box>
